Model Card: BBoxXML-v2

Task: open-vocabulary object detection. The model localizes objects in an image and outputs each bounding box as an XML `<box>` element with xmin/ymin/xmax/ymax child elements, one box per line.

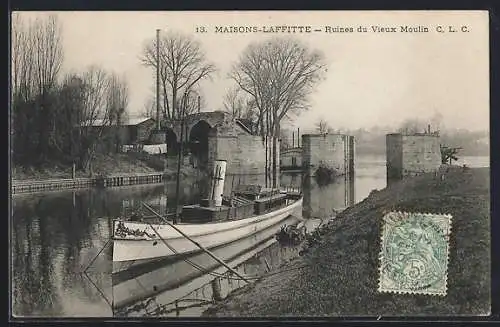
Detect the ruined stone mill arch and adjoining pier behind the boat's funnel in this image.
<box><xmin>167</xmin><ymin>111</ymin><xmax>280</xmax><ymax>195</ymax></box>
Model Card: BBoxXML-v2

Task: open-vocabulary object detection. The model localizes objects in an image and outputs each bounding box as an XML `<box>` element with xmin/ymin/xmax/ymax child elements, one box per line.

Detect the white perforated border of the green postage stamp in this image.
<box><xmin>378</xmin><ymin>211</ymin><xmax>453</xmax><ymax>297</ymax></box>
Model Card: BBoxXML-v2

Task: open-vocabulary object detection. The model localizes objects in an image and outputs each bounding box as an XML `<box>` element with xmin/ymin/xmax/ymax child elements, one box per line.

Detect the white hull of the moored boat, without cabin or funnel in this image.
<box><xmin>113</xmin><ymin>198</ymin><xmax>302</xmax><ymax>273</ymax></box>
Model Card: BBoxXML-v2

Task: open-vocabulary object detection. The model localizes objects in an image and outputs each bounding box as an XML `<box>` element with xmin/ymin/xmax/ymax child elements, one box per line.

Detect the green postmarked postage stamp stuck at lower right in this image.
<box><xmin>378</xmin><ymin>212</ymin><xmax>452</xmax><ymax>296</ymax></box>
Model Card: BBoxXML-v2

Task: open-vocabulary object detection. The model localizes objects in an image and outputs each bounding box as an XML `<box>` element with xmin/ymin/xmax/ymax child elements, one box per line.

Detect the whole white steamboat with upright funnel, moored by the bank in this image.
<box><xmin>113</xmin><ymin>160</ymin><xmax>303</xmax><ymax>273</ymax></box>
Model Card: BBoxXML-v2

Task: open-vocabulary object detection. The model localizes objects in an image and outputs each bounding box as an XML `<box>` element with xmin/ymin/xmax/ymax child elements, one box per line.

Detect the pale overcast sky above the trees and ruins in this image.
<box><xmin>11</xmin><ymin>11</ymin><xmax>489</xmax><ymax>130</ymax></box>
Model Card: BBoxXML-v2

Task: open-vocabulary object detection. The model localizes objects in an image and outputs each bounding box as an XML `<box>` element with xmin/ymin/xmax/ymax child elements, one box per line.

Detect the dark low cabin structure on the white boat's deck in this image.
<box><xmin>182</xmin><ymin>185</ymin><xmax>289</xmax><ymax>223</ymax></box>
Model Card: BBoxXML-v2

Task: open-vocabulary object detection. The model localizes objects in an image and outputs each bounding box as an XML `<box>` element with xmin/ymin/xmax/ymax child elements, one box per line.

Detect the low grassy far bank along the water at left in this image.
<box><xmin>12</xmin><ymin>153</ymin><xmax>197</xmax><ymax>180</ymax></box>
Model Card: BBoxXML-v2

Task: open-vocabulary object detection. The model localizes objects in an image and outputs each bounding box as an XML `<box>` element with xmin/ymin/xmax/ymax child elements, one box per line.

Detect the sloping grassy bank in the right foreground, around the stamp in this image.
<box><xmin>204</xmin><ymin>168</ymin><xmax>491</xmax><ymax>317</ymax></box>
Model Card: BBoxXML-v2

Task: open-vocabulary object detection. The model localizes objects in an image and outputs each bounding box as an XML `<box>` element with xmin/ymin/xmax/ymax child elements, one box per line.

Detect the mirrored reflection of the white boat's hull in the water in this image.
<box><xmin>112</xmin><ymin>217</ymin><xmax>299</xmax><ymax>311</ymax></box>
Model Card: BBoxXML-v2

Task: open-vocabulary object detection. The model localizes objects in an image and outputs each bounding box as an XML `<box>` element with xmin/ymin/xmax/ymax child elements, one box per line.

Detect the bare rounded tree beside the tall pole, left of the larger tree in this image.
<box><xmin>140</xmin><ymin>32</ymin><xmax>215</xmax><ymax>120</ymax></box>
